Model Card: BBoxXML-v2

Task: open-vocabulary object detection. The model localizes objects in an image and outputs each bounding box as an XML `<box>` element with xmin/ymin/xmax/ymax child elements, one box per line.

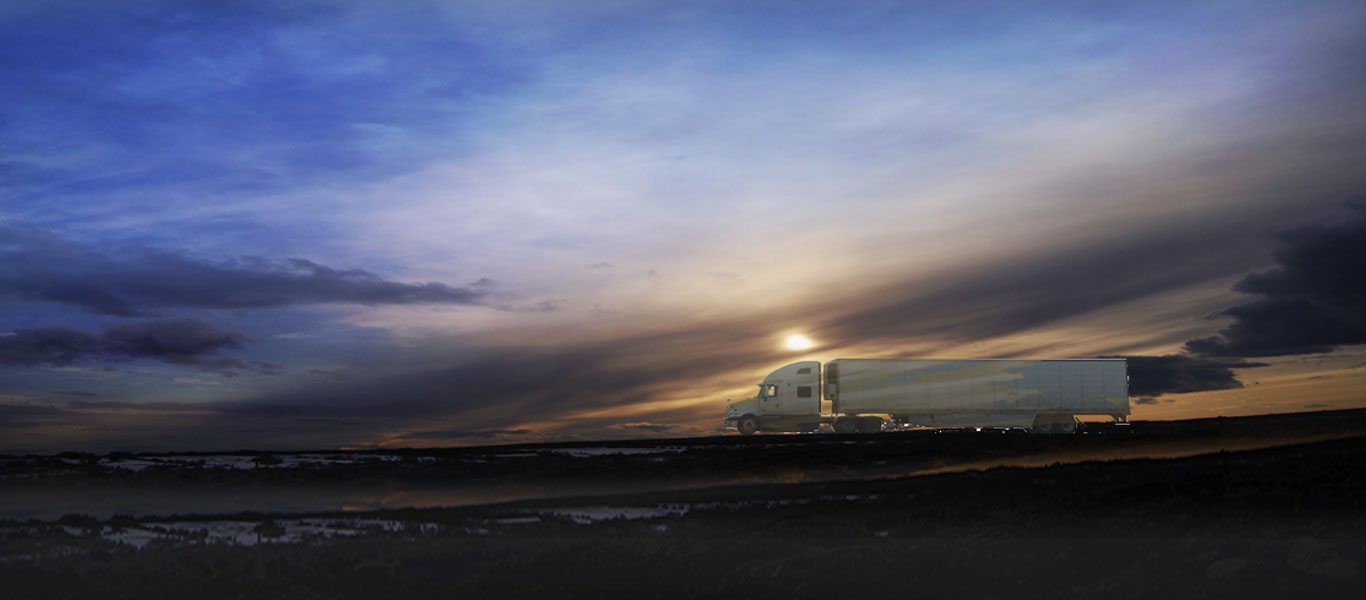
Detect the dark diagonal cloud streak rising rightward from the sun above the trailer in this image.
<box><xmin>817</xmin><ymin>219</ymin><xmax>1257</xmax><ymax>344</ymax></box>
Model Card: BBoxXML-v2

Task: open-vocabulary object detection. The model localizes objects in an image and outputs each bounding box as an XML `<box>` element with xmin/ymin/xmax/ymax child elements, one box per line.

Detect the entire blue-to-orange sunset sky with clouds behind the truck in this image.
<box><xmin>0</xmin><ymin>0</ymin><xmax>1366</xmax><ymax>452</ymax></box>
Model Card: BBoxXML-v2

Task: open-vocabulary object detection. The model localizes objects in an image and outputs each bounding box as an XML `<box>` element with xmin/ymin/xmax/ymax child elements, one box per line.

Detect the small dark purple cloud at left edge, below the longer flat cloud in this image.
<box><xmin>0</xmin><ymin>318</ymin><xmax>274</xmax><ymax>376</ymax></box>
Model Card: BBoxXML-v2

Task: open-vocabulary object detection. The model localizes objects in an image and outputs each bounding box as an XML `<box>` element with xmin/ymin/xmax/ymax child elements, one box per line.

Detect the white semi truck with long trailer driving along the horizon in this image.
<box><xmin>724</xmin><ymin>358</ymin><xmax>1130</xmax><ymax>435</ymax></box>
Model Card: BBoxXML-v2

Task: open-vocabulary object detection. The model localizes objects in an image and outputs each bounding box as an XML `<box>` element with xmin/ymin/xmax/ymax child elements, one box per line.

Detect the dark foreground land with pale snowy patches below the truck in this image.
<box><xmin>0</xmin><ymin>411</ymin><xmax>1366</xmax><ymax>597</ymax></box>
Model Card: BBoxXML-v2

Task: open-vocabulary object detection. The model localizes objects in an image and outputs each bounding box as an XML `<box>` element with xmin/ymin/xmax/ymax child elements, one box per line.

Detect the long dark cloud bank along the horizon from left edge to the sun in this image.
<box><xmin>0</xmin><ymin>321</ymin><xmax>785</xmax><ymax>451</ymax></box>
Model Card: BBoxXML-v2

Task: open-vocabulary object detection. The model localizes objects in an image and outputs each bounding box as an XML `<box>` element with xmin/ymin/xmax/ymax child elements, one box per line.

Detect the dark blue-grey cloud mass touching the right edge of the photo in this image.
<box><xmin>1186</xmin><ymin>201</ymin><xmax>1366</xmax><ymax>357</ymax></box>
